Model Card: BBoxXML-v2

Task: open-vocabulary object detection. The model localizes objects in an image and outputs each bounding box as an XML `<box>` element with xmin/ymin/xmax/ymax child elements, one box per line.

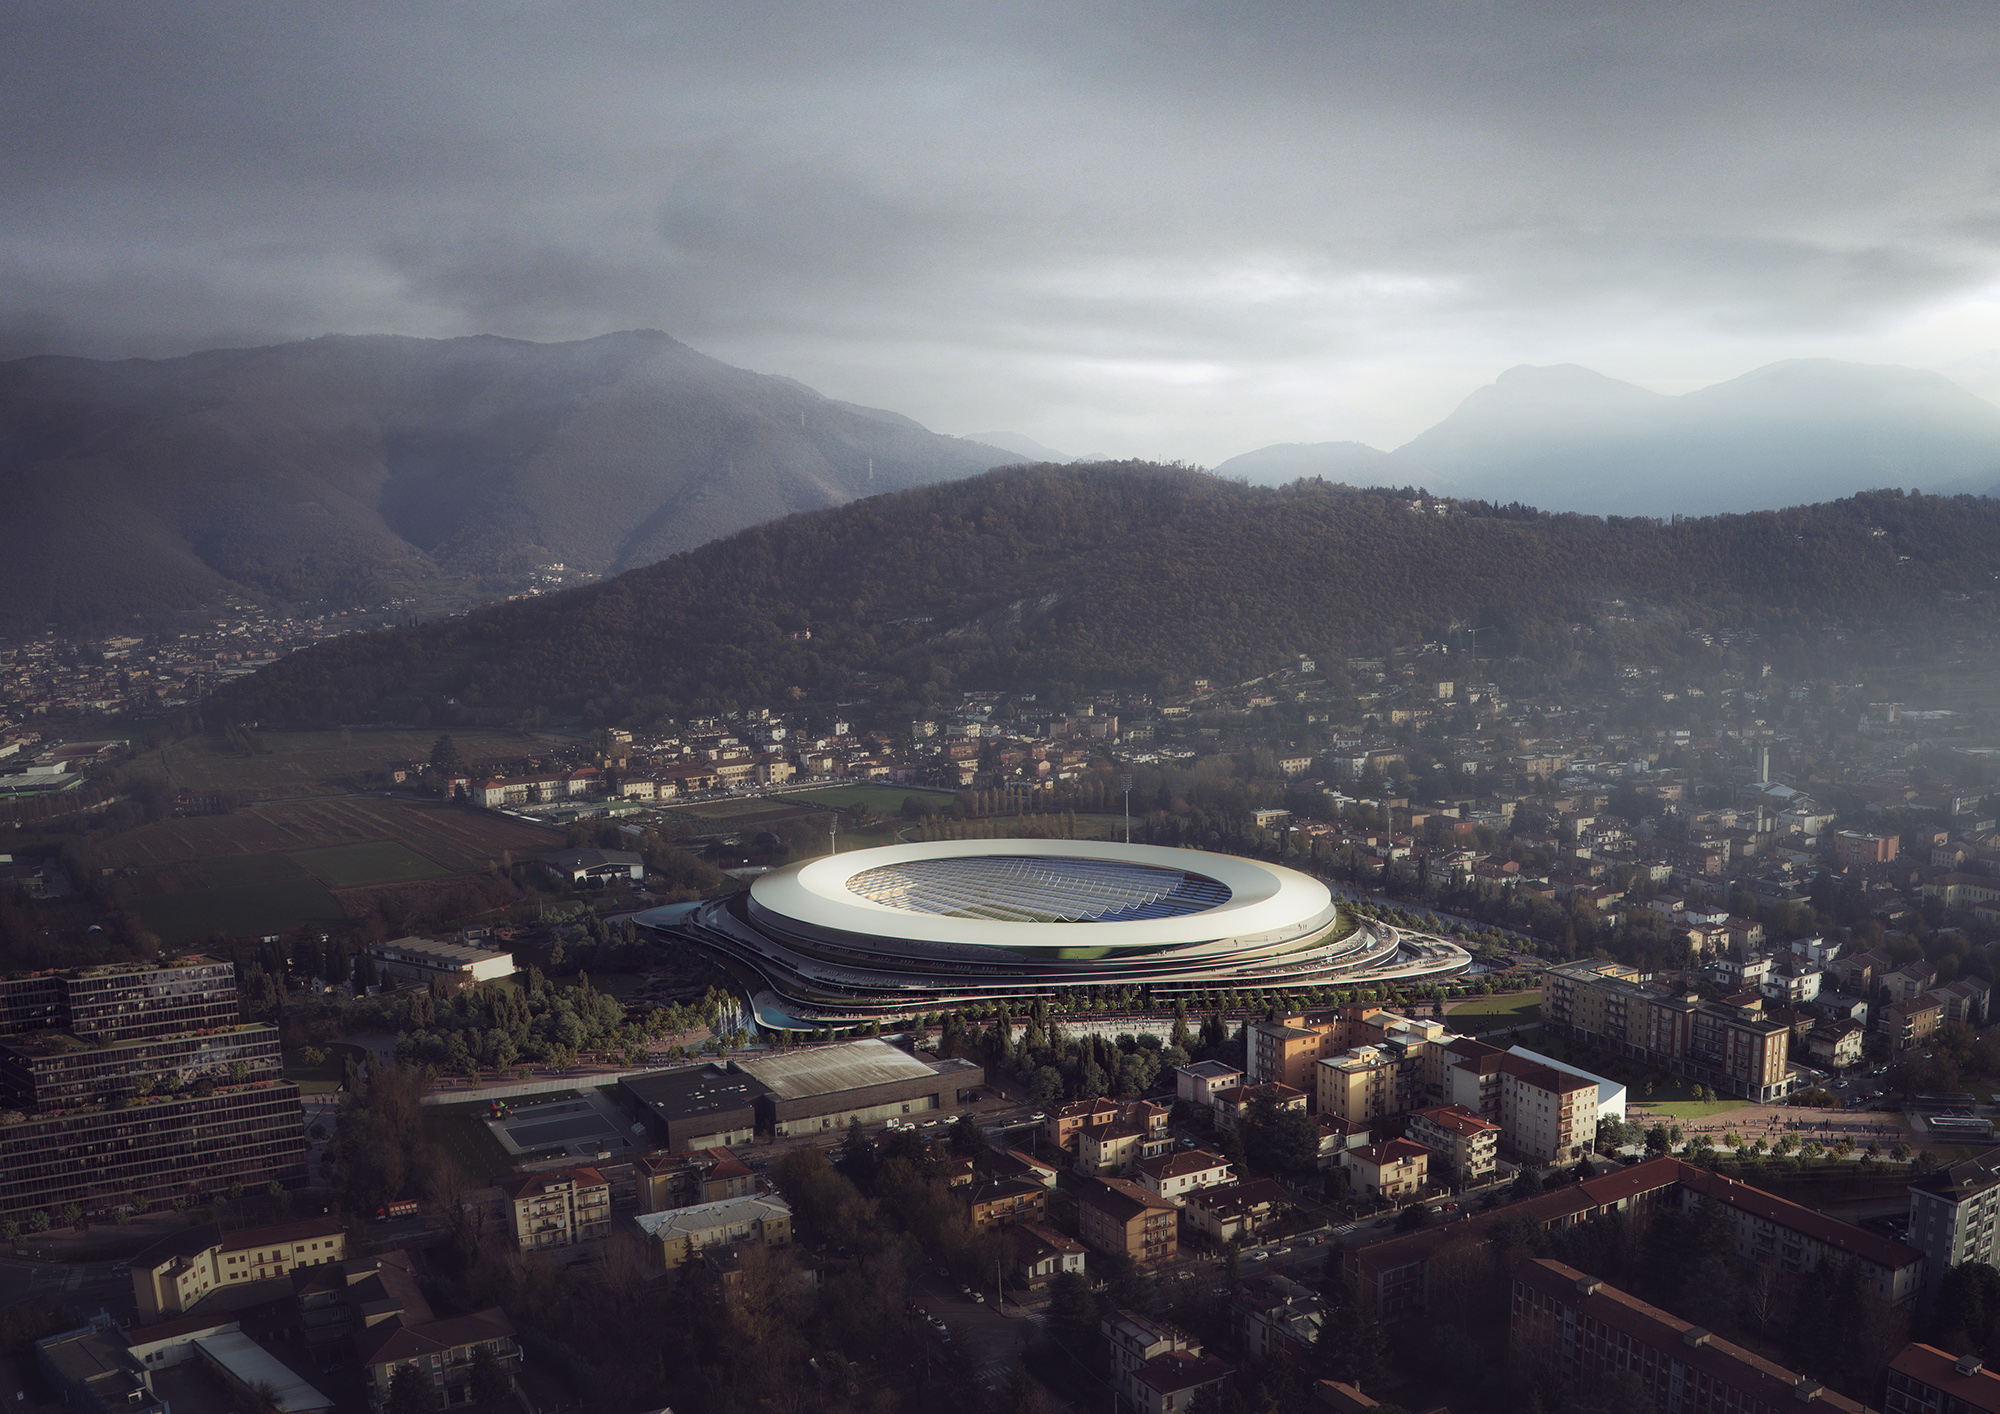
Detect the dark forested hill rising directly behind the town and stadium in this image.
<box><xmin>220</xmin><ymin>464</ymin><xmax>2000</xmax><ymax>722</ymax></box>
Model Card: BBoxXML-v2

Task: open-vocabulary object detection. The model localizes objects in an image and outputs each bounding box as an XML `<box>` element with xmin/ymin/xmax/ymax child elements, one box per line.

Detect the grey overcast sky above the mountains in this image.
<box><xmin>0</xmin><ymin>0</ymin><xmax>2000</xmax><ymax>464</ymax></box>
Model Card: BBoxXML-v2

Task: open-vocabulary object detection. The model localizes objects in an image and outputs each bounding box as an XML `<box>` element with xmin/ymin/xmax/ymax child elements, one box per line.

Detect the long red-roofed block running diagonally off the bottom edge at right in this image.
<box><xmin>1508</xmin><ymin>1258</ymin><xmax>1866</xmax><ymax>1414</ymax></box>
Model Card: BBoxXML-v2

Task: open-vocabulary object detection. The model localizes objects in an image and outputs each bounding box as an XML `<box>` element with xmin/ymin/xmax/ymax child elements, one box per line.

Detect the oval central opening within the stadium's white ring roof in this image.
<box><xmin>848</xmin><ymin>856</ymin><xmax>1230</xmax><ymax>924</ymax></box>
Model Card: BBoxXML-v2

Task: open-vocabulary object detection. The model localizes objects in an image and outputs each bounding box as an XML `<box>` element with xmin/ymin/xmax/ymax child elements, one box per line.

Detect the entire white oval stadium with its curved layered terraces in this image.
<box><xmin>640</xmin><ymin>840</ymin><xmax>1470</xmax><ymax>1030</ymax></box>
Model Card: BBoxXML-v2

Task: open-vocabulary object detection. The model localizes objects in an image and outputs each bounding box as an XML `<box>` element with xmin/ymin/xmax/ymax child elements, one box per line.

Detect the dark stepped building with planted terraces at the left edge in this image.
<box><xmin>0</xmin><ymin>958</ymin><xmax>306</xmax><ymax>1220</ymax></box>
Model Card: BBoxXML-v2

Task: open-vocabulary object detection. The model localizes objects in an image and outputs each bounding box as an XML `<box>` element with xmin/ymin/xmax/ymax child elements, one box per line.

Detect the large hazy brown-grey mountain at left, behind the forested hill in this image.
<box><xmin>0</xmin><ymin>330</ymin><xmax>1018</xmax><ymax>624</ymax></box>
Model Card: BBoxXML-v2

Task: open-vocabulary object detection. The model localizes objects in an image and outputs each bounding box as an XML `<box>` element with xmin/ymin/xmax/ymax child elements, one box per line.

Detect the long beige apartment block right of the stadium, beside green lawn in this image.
<box><xmin>1544</xmin><ymin>960</ymin><xmax>1792</xmax><ymax>1108</ymax></box>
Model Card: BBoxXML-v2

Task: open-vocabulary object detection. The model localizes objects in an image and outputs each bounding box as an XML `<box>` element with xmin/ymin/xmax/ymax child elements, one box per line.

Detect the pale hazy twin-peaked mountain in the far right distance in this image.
<box><xmin>1396</xmin><ymin>358</ymin><xmax>2000</xmax><ymax>516</ymax></box>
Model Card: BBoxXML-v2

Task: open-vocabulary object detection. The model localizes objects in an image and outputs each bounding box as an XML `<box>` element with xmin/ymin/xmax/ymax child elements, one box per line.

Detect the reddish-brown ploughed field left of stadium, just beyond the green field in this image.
<box><xmin>104</xmin><ymin>796</ymin><xmax>562</xmax><ymax>878</ymax></box>
